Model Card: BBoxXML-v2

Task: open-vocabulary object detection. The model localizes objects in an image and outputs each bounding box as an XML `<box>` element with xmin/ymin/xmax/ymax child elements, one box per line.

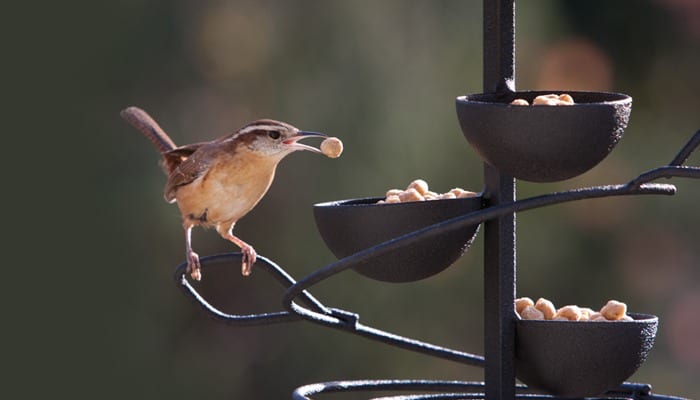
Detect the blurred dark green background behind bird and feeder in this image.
<box><xmin>2</xmin><ymin>0</ymin><xmax>700</xmax><ymax>399</ymax></box>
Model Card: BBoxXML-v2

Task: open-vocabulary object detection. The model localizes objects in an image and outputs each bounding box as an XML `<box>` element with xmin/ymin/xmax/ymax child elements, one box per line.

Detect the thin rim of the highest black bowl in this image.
<box><xmin>457</xmin><ymin>89</ymin><xmax>632</xmax><ymax>110</ymax></box>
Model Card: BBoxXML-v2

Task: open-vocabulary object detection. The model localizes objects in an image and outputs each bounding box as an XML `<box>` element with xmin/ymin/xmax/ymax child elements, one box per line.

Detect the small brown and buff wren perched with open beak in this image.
<box><xmin>120</xmin><ymin>106</ymin><xmax>327</xmax><ymax>281</ymax></box>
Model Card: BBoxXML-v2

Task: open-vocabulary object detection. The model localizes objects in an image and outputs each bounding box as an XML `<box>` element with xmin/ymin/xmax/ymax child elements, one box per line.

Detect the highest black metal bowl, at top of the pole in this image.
<box><xmin>457</xmin><ymin>91</ymin><xmax>632</xmax><ymax>182</ymax></box>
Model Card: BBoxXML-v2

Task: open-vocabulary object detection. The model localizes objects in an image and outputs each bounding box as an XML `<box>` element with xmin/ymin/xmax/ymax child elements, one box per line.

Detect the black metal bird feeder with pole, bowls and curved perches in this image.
<box><xmin>175</xmin><ymin>0</ymin><xmax>700</xmax><ymax>400</ymax></box>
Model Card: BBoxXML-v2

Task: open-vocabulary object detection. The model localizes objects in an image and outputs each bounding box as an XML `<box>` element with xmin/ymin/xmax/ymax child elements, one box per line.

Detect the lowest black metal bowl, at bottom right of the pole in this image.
<box><xmin>515</xmin><ymin>314</ymin><xmax>659</xmax><ymax>397</ymax></box>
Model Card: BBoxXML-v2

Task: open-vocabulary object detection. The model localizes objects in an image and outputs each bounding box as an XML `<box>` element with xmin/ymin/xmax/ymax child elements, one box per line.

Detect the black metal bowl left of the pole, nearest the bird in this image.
<box><xmin>314</xmin><ymin>195</ymin><xmax>482</xmax><ymax>282</ymax></box>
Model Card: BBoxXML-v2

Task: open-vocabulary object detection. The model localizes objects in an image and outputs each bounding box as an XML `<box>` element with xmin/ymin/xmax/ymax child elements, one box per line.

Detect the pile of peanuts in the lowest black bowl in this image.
<box><xmin>515</xmin><ymin>297</ymin><xmax>633</xmax><ymax>321</ymax></box>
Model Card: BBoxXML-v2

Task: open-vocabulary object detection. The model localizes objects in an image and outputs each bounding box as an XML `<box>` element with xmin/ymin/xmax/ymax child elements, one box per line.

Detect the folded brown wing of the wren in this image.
<box><xmin>163</xmin><ymin>143</ymin><xmax>216</xmax><ymax>203</ymax></box>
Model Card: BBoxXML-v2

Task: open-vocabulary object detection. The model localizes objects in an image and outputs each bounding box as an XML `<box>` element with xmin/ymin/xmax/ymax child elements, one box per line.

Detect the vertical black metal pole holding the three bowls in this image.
<box><xmin>483</xmin><ymin>0</ymin><xmax>515</xmax><ymax>400</ymax></box>
